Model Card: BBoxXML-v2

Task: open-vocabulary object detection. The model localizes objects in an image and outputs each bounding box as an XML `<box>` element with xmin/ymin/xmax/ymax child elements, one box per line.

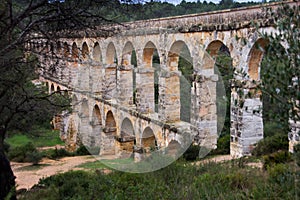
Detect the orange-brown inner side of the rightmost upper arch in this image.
<box><xmin>248</xmin><ymin>38</ymin><xmax>268</xmax><ymax>80</ymax></box>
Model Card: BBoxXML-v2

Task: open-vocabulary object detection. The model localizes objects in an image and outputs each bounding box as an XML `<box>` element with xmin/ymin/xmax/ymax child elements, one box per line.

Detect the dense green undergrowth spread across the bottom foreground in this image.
<box><xmin>20</xmin><ymin>160</ymin><xmax>299</xmax><ymax>200</ymax></box>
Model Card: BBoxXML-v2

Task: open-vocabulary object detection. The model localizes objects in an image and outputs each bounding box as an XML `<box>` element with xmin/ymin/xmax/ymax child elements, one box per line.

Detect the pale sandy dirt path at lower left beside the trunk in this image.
<box><xmin>11</xmin><ymin>156</ymin><xmax>96</xmax><ymax>189</ymax></box>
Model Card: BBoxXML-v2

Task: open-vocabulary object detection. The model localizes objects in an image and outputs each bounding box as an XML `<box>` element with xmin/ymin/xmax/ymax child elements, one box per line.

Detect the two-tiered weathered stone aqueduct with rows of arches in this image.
<box><xmin>32</xmin><ymin>1</ymin><xmax>299</xmax><ymax>157</ymax></box>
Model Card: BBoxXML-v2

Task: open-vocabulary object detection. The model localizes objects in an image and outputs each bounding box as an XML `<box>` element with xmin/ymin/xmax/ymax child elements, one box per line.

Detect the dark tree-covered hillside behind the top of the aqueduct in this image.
<box><xmin>99</xmin><ymin>0</ymin><xmax>258</xmax><ymax>22</ymax></box>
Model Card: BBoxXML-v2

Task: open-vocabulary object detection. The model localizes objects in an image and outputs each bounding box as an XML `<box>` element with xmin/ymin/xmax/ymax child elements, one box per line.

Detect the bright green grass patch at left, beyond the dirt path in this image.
<box><xmin>6</xmin><ymin>128</ymin><xmax>64</xmax><ymax>148</ymax></box>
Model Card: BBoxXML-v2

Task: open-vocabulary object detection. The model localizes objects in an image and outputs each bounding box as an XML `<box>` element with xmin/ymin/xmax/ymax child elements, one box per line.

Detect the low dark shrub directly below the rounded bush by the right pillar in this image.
<box><xmin>263</xmin><ymin>151</ymin><xmax>292</xmax><ymax>169</ymax></box>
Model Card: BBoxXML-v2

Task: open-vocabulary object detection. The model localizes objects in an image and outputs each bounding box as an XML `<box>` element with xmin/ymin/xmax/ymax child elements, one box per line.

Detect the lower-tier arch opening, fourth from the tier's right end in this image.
<box><xmin>100</xmin><ymin>111</ymin><xmax>117</xmax><ymax>155</ymax></box>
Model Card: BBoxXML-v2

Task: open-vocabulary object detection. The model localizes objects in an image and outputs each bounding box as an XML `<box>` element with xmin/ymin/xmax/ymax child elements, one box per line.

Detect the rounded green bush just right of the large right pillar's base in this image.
<box><xmin>252</xmin><ymin>134</ymin><xmax>289</xmax><ymax>156</ymax></box>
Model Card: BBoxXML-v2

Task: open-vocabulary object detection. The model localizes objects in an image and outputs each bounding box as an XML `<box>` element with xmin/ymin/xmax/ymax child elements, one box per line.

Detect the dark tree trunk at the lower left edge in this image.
<box><xmin>0</xmin><ymin>128</ymin><xmax>16</xmax><ymax>200</ymax></box>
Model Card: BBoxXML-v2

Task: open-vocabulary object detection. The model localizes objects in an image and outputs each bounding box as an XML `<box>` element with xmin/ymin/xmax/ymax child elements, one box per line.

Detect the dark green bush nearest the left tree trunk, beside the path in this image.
<box><xmin>8</xmin><ymin>142</ymin><xmax>42</xmax><ymax>164</ymax></box>
